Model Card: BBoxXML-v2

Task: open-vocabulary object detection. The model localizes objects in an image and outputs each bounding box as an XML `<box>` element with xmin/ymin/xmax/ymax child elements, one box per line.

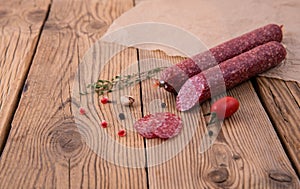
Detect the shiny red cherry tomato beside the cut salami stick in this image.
<box><xmin>210</xmin><ymin>96</ymin><xmax>240</xmax><ymax>120</ymax></box>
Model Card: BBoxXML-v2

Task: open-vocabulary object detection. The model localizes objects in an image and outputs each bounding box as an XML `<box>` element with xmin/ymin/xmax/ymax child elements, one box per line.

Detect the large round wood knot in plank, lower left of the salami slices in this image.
<box><xmin>58</xmin><ymin>130</ymin><xmax>82</xmax><ymax>153</ymax></box>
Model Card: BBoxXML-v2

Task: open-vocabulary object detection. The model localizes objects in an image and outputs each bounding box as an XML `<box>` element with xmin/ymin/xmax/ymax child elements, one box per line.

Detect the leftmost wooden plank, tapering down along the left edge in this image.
<box><xmin>0</xmin><ymin>0</ymin><xmax>50</xmax><ymax>153</ymax></box>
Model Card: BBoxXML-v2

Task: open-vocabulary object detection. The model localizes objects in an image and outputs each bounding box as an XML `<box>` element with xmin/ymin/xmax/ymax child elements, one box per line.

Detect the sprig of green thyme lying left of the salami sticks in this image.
<box><xmin>81</xmin><ymin>67</ymin><xmax>167</xmax><ymax>95</ymax></box>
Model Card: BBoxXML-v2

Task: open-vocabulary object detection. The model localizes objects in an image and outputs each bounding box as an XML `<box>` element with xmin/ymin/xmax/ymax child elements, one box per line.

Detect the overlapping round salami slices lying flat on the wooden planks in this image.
<box><xmin>134</xmin><ymin>112</ymin><xmax>182</xmax><ymax>139</ymax></box>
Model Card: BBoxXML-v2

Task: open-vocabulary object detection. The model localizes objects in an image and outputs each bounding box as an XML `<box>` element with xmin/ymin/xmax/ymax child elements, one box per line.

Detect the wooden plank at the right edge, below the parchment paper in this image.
<box><xmin>256</xmin><ymin>77</ymin><xmax>300</xmax><ymax>175</ymax></box>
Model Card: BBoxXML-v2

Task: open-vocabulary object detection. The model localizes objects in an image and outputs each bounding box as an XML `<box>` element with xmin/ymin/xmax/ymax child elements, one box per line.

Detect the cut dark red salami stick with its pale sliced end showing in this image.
<box><xmin>176</xmin><ymin>41</ymin><xmax>286</xmax><ymax>111</ymax></box>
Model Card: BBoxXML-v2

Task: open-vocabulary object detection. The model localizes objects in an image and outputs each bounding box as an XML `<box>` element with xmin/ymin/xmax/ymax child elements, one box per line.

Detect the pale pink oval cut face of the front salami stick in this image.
<box><xmin>176</xmin><ymin>75</ymin><xmax>206</xmax><ymax>111</ymax></box>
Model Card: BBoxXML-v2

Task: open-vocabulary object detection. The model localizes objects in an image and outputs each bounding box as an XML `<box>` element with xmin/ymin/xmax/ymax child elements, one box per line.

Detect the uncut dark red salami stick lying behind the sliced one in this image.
<box><xmin>161</xmin><ymin>24</ymin><xmax>282</xmax><ymax>93</ymax></box>
